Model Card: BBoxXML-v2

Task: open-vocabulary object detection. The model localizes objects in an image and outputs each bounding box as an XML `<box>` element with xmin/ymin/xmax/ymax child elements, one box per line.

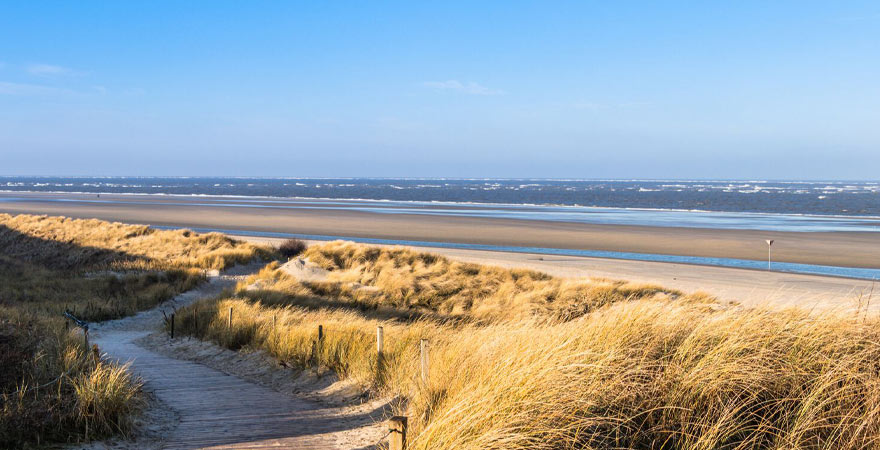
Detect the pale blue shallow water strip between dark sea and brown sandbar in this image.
<box><xmin>0</xmin><ymin>190</ymin><xmax>880</xmax><ymax>233</ymax></box>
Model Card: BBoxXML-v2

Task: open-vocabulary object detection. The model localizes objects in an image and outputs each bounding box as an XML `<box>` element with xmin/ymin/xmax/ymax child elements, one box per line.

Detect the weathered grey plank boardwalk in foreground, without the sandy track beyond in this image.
<box><xmin>96</xmin><ymin>331</ymin><xmax>370</xmax><ymax>450</ymax></box>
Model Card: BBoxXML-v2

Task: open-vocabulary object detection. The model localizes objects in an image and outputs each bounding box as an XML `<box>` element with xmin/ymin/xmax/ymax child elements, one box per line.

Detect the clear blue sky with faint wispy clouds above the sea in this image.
<box><xmin>0</xmin><ymin>1</ymin><xmax>880</xmax><ymax>179</ymax></box>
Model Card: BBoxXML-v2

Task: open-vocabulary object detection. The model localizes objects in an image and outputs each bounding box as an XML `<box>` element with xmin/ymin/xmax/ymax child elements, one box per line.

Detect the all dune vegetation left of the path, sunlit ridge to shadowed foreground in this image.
<box><xmin>0</xmin><ymin>214</ymin><xmax>274</xmax><ymax>448</ymax></box>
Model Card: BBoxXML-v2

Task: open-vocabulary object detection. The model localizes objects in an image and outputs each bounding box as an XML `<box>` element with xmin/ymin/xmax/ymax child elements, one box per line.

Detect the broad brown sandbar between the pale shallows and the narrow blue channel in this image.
<box><xmin>0</xmin><ymin>190</ymin><xmax>880</xmax><ymax>269</ymax></box>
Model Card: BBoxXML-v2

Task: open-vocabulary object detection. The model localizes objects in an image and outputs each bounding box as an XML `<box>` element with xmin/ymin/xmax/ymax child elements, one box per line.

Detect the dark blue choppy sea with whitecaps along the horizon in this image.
<box><xmin>0</xmin><ymin>177</ymin><xmax>880</xmax><ymax>220</ymax></box>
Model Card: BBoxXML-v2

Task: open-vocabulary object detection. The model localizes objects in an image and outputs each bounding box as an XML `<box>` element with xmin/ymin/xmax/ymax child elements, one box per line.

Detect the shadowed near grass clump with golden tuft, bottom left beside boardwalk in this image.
<box><xmin>0</xmin><ymin>307</ymin><xmax>144</xmax><ymax>448</ymax></box>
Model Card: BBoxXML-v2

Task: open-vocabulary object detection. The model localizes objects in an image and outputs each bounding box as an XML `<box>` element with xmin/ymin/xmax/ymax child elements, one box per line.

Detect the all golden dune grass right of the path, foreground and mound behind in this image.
<box><xmin>172</xmin><ymin>243</ymin><xmax>880</xmax><ymax>450</ymax></box>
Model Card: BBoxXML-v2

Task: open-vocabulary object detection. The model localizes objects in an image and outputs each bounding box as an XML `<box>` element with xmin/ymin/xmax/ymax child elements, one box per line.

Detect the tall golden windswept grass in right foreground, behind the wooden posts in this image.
<box><xmin>179</xmin><ymin>290</ymin><xmax>880</xmax><ymax>449</ymax></box>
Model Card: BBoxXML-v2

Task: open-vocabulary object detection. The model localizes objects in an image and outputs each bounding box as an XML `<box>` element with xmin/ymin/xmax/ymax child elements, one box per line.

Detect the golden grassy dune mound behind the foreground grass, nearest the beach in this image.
<box><xmin>300</xmin><ymin>241</ymin><xmax>681</xmax><ymax>321</ymax></box>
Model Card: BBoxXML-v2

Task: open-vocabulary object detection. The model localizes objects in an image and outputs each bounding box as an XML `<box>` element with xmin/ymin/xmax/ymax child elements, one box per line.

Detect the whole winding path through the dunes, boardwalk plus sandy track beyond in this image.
<box><xmin>88</xmin><ymin>267</ymin><xmax>384</xmax><ymax>449</ymax></box>
